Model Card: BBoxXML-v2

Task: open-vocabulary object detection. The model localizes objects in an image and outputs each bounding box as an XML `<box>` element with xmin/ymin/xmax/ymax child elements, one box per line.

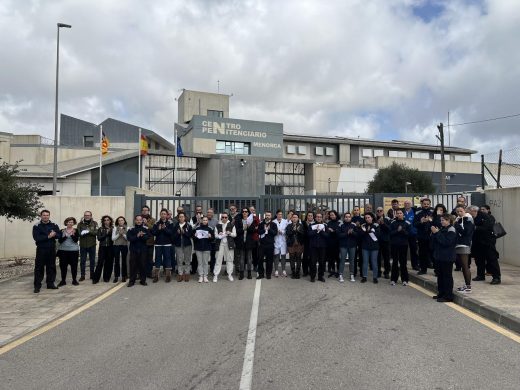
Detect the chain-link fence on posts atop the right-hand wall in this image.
<box><xmin>481</xmin><ymin>146</ymin><xmax>520</xmax><ymax>188</ymax></box>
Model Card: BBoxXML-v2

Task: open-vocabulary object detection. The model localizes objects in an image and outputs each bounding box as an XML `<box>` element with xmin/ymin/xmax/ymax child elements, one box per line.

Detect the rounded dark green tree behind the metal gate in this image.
<box><xmin>367</xmin><ymin>162</ymin><xmax>435</xmax><ymax>194</ymax></box>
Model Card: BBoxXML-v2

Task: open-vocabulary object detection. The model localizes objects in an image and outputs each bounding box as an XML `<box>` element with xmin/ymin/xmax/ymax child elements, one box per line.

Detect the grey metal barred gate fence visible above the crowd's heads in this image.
<box><xmin>134</xmin><ymin>192</ymin><xmax>485</xmax><ymax>218</ymax></box>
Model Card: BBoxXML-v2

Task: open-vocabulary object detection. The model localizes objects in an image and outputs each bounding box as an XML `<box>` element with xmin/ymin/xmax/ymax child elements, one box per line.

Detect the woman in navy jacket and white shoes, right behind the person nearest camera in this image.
<box><xmin>453</xmin><ymin>206</ymin><xmax>475</xmax><ymax>293</ymax></box>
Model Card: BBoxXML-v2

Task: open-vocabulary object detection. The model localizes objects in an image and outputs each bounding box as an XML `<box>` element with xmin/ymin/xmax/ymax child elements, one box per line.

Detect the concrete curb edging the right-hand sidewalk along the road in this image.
<box><xmin>409</xmin><ymin>271</ymin><xmax>520</xmax><ymax>334</ymax></box>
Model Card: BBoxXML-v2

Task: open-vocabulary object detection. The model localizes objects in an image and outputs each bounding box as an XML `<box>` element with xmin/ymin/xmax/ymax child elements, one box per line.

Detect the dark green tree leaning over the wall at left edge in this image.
<box><xmin>0</xmin><ymin>162</ymin><xmax>43</xmax><ymax>221</ymax></box>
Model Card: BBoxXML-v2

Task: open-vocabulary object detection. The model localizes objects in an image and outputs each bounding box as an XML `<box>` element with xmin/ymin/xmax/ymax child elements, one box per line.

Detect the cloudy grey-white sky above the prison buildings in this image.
<box><xmin>0</xmin><ymin>0</ymin><xmax>520</xmax><ymax>153</ymax></box>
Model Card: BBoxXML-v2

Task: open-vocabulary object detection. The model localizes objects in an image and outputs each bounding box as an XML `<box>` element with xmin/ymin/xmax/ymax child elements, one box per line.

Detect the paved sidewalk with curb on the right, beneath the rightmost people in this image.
<box><xmin>408</xmin><ymin>263</ymin><xmax>520</xmax><ymax>333</ymax></box>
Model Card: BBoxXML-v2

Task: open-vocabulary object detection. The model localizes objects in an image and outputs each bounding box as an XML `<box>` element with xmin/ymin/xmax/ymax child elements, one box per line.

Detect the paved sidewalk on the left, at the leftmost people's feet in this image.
<box><xmin>0</xmin><ymin>273</ymin><xmax>119</xmax><ymax>347</ymax></box>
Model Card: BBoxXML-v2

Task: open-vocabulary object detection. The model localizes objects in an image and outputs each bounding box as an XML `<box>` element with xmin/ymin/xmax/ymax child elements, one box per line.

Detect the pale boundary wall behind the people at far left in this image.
<box><xmin>0</xmin><ymin>196</ymin><xmax>125</xmax><ymax>258</ymax></box>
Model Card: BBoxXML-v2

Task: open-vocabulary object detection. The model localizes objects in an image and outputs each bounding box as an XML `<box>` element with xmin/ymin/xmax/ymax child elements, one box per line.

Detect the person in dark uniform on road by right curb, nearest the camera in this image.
<box><xmin>430</xmin><ymin>214</ymin><xmax>457</xmax><ymax>302</ymax></box>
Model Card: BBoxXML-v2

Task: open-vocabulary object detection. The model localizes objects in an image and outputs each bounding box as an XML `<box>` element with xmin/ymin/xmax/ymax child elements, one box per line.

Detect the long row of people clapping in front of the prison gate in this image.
<box><xmin>33</xmin><ymin>197</ymin><xmax>500</xmax><ymax>302</ymax></box>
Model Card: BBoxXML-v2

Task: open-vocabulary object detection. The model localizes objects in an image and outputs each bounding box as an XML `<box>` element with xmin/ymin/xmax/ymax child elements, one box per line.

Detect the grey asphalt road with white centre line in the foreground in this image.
<box><xmin>0</xmin><ymin>279</ymin><xmax>520</xmax><ymax>390</ymax></box>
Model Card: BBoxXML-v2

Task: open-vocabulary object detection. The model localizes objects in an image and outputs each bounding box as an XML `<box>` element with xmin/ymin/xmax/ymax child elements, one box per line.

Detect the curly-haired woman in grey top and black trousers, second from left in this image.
<box><xmin>57</xmin><ymin>217</ymin><xmax>79</xmax><ymax>287</ymax></box>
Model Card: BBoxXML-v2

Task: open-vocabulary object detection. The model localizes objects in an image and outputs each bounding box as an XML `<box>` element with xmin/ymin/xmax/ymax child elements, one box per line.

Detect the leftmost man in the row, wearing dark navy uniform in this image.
<box><xmin>32</xmin><ymin>210</ymin><xmax>61</xmax><ymax>294</ymax></box>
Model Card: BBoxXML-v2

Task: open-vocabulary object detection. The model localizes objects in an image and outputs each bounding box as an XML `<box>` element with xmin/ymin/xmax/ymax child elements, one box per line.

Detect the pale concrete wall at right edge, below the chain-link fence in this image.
<box><xmin>485</xmin><ymin>187</ymin><xmax>520</xmax><ymax>266</ymax></box>
